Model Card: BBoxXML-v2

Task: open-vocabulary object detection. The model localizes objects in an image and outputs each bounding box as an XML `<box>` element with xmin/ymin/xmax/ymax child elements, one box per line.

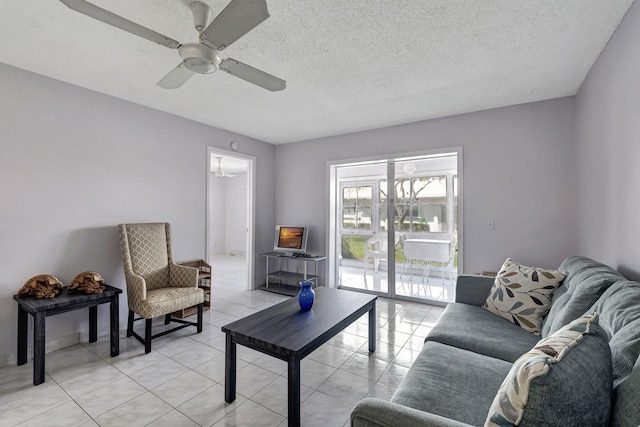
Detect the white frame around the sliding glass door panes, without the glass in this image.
<box><xmin>326</xmin><ymin>146</ymin><xmax>464</xmax><ymax>304</ymax></box>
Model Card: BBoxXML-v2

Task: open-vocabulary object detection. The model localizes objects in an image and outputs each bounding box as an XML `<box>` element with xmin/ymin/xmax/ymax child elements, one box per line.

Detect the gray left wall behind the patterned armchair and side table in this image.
<box><xmin>0</xmin><ymin>64</ymin><xmax>275</xmax><ymax>365</ymax></box>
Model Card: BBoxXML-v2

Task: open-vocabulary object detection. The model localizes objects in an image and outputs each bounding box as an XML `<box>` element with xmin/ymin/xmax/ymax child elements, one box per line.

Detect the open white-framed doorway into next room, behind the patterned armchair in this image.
<box><xmin>205</xmin><ymin>147</ymin><xmax>255</xmax><ymax>289</ymax></box>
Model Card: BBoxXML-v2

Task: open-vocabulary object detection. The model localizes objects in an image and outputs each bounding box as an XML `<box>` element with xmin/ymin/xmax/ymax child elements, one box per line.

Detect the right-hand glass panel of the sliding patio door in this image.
<box><xmin>392</xmin><ymin>156</ymin><xmax>458</xmax><ymax>302</ymax></box>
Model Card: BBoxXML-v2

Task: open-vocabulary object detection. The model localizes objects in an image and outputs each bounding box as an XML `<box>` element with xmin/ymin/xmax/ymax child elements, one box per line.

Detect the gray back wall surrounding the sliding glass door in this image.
<box><xmin>276</xmin><ymin>98</ymin><xmax>576</xmax><ymax>278</ymax></box>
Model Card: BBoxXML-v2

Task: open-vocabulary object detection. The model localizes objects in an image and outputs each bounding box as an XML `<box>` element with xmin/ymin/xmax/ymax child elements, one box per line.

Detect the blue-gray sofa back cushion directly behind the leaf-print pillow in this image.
<box><xmin>542</xmin><ymin>256</ymin><xmax>624</xmax><ymax>337</ymax></box>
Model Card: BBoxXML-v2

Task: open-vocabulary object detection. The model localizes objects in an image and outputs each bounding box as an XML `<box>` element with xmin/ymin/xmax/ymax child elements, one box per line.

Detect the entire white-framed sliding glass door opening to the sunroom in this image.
<box><xmin>328</xmin><ymin>148</ymin><xmax>462</xmax><ymax>303</ymax></box>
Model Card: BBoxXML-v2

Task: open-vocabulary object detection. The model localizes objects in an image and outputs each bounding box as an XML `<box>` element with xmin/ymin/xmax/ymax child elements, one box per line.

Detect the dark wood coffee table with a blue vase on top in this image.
<box><xmin>222</xmin><ymin>287</ymin><xmax>378</xmax><ymax>426</ymax></box>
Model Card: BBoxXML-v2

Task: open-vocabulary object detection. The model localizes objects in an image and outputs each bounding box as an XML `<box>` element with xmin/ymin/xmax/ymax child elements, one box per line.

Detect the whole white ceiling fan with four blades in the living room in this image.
<box><xmin>60</xmin><ymin>0</ymin><xmax>287</xmax><ymax>92</ymax></box>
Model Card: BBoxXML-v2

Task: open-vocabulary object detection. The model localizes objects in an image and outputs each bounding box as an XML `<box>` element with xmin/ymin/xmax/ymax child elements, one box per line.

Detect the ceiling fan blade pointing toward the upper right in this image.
<box><xmin>200</xmin><ymin>0</ymin><xmax>269</xmax><ymax>50</ymax></box>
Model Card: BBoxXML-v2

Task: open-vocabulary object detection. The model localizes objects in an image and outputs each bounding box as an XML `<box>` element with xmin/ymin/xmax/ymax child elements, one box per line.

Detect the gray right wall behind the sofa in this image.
<box><xmin>576</xmin><ymin>2</ymin><xmax>640</xmax><ymax>280</ymax></box>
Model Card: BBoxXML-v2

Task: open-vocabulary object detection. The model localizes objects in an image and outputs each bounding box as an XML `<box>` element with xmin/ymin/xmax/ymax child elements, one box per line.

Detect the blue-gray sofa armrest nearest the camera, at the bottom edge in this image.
<box><xmin>351</xmin><ymin>397</ymin><xmax>470</xmax><ymax>427</ymax></box>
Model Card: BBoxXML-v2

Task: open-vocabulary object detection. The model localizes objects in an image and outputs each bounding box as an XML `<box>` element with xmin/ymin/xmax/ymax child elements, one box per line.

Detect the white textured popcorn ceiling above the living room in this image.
<box><xmin>0</xmin><ymin>0</ymin><xmax>633</xmax><ymax>144</ymax></box>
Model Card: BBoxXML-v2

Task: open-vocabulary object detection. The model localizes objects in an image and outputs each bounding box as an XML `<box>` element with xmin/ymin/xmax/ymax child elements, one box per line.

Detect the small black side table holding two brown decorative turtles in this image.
<box><xmin>13</xmin><ymin>285</ymin><xmax>122</xmax><ymax>385</ymax></box>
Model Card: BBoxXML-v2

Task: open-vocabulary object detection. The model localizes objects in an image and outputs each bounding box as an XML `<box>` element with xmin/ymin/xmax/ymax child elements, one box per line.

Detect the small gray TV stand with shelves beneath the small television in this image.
<box><xmin>261</xmin><ymin>252</ymin><xmax>327</xmax><ymax>289</ymax></box>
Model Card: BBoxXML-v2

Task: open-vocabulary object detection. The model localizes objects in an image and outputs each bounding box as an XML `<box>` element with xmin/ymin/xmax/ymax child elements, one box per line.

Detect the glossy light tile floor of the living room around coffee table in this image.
<box><xmin>0</xmin><ymin>257</ymin><xmax>443</xmax><ymax>427</ymax></box>
